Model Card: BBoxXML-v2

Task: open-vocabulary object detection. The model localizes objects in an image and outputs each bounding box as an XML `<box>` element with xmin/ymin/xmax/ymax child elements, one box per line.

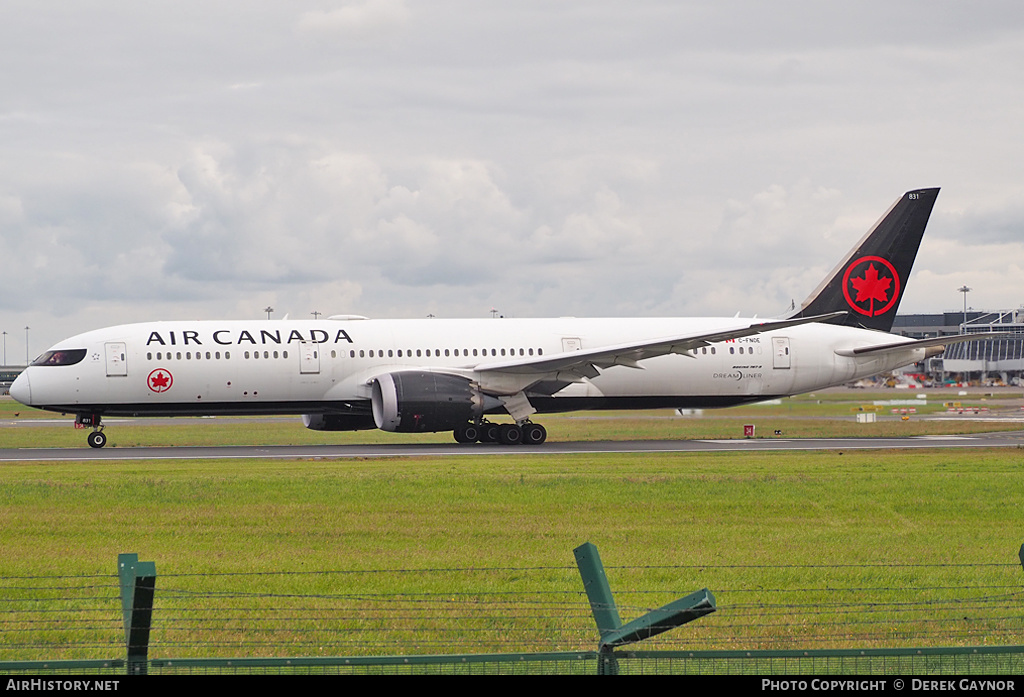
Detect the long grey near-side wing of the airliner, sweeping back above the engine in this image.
<box><xmin>474</xmin><ymin>312</ymin><xmax>846</xmax><ymax>378</ymax></box>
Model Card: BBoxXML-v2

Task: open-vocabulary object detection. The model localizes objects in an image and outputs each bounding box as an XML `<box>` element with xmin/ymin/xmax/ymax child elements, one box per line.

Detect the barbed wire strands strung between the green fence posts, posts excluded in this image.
<box><xmin>0</xmin><ymin>564</ymin><xmax>1024</xmax><ymax>672</ymax></box>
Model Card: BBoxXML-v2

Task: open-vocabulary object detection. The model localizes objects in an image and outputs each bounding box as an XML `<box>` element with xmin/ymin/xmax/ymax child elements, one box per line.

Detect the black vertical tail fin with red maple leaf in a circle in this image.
<box><xmin>792</xmin><ymin>188</ymin><xmax>939</xmax><ymax>332</ymax></box>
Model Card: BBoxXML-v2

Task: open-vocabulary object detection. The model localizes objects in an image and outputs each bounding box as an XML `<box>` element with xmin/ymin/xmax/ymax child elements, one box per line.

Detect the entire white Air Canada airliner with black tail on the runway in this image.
<box><xmin>10</xmin><ymin>188</ymin><xmax>986</xmax><ymax>447</ymax></box>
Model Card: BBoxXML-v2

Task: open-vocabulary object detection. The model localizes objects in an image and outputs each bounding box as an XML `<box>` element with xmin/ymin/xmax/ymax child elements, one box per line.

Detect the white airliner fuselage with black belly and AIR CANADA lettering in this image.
<box><xmin>11</xmin><ymin>317</ymin><xmax>925</xmax><ymax>419</ymax></box>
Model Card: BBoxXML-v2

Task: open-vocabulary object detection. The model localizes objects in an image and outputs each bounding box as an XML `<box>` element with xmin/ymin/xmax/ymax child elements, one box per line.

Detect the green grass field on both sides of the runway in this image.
<box><xmin>0</xmin><ymin>392</ymin><xmax>1024</xmax><ymax>660</ymax></box>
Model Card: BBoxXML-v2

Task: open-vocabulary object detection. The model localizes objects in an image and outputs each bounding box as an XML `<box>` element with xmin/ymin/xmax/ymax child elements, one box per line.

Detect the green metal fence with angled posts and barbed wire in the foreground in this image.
<box><xmin>0</xmin><ymin>546</ymin><xmax>1024</xmax><ymax>675</ymax></box>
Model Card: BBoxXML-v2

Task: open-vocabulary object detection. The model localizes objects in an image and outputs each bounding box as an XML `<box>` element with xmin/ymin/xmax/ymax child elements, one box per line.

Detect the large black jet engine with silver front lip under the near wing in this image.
<box><xmin>371</xmin><ymin>371</ymin><xmax>501</xmax><ymax>433</ymax></box>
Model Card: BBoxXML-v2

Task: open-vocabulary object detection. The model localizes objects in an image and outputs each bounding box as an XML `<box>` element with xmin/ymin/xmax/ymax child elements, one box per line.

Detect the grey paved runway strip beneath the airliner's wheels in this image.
<box><xmin>0</xmin><ymin>431</ymin><xmax>1024</xmax><ymax>463</ymax></box>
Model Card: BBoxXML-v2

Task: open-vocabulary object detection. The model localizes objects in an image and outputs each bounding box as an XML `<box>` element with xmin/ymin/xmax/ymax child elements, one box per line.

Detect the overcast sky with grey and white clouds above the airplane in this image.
<box><xmin>0</xmin><ymin>0</ymin><xmax>1024</xmax><ymax>363</ymax></box>
